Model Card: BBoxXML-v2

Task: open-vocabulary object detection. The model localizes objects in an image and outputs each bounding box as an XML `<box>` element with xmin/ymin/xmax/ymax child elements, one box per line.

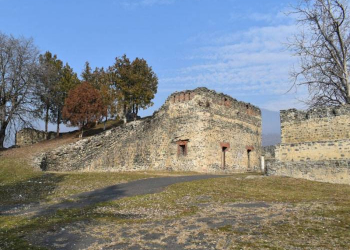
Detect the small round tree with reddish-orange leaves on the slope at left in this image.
<box><xmin>62</xmin><ymin>82</ymin><xmax>107</xmax><ymax>137</ymax></box>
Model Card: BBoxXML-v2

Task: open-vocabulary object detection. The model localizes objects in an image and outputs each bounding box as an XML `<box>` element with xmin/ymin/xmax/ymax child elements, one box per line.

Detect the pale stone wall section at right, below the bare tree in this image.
<box><xmin>266</xmin><ymin>106</ymin><xmax>350</xmax><ymax>184</ymax></box>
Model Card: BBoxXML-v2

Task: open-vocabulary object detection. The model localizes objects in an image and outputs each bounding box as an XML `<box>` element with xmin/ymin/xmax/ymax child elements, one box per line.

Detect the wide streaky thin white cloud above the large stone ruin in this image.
<box><xmin>161</xmin><ymin>25</ymin><xmax>295</xmax><ymax>99</ymax></box>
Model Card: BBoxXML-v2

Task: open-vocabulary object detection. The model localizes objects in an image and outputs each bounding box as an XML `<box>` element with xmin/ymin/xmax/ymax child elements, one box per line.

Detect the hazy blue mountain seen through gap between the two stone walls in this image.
<box><xmin>261</xmin><ymin>109</ymin><xmax>281</xmax><ymax>146</ymax></box>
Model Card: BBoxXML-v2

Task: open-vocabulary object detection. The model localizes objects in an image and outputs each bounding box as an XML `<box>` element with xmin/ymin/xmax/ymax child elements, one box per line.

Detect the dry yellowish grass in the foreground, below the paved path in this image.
<box><xmin>0</xmin><ymin>174</ymin><xmax>350</xmax><ymax>249</ymax></box>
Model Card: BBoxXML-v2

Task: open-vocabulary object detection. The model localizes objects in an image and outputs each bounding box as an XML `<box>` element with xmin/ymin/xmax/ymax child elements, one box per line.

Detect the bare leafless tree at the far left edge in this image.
<box><xmin>0</xmin><ymin>33</ymin><xmax>38</xmax><ymax>149</ymax></box>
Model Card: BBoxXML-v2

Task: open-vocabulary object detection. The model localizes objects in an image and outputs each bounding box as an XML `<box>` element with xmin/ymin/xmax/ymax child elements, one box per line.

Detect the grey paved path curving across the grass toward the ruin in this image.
<box><xmin>0</xmin><ymin>175</ymin><xmax>224</xmax><ymax>216</ymax></box>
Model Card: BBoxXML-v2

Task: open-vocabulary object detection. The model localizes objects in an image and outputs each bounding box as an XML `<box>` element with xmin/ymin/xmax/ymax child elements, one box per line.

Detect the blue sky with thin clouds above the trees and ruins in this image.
<box><xmin>0</xmin><ymin>0</ymin><xmax>306</xmax><ymax>136</ymax></box>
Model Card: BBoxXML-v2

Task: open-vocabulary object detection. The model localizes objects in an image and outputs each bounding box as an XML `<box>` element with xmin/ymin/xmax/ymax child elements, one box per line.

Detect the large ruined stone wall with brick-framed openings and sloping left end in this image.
<box><xmin>35</xmin><ymin>88</ymin><xmax>261</xmax><ymax>173</ymax></box>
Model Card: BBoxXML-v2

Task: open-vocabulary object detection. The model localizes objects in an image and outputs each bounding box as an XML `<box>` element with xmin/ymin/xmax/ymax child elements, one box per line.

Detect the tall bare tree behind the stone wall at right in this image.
<box><xmin>289</xmin><ymin>0</ymin><xmax>350</xmax><ymax>107</ymax></box>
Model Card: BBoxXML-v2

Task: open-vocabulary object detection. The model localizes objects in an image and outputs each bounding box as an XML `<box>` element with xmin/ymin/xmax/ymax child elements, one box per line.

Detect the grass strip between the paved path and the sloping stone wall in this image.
<box><xmin>0</xmin><ymin>158</ymin><xmax>161</xmax><ymax>205</ymax></box>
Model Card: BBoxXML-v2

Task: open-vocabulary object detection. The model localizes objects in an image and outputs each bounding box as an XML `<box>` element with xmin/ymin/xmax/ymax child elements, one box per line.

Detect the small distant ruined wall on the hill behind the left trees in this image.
<box><xmin>16</xmin><ymin>128</ymin><xmax>56</xmax><ymax>147</ymax></box>
